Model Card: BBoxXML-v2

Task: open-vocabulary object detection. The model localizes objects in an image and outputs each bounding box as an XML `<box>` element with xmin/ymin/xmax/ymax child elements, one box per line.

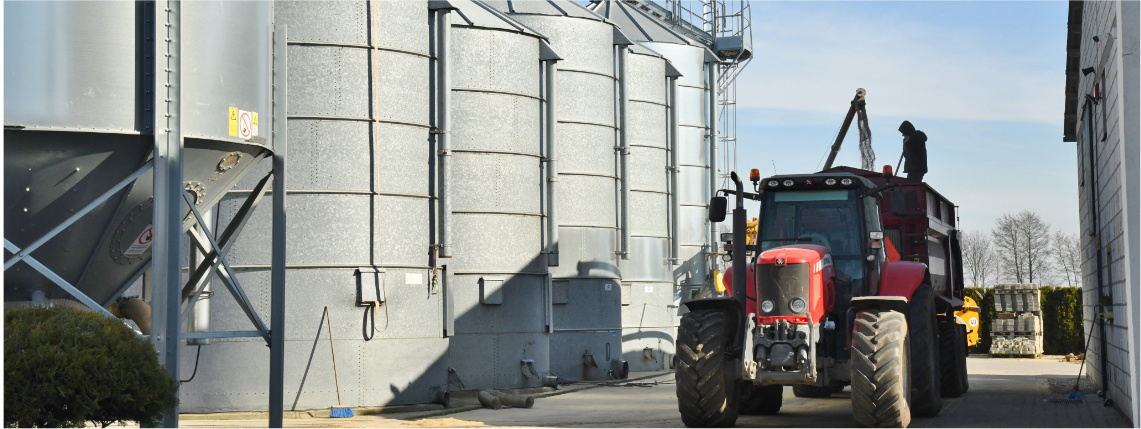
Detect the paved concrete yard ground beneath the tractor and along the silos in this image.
<box><xmin>180</xmin><ymin>356</ymin><xmax>1132</xmax><ymax>428</ymax></box>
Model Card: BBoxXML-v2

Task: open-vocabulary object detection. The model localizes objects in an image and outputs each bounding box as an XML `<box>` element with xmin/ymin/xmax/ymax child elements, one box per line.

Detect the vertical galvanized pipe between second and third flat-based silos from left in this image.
<box><xmin>539</xmin><ymin>40</ymin><xmax>563</xmax><ymax>266</ymax></box>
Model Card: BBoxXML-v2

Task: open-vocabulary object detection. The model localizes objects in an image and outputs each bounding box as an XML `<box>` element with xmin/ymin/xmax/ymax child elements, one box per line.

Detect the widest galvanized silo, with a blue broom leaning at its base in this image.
<box><xmin>181</xmin><ymin>1</ymin><xmax>447</xmax><ymax>412</ymax></box>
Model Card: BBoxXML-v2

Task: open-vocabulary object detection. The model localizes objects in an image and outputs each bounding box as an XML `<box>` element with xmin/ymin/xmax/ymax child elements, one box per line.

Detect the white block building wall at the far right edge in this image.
<box><xmin>1077</xmin><ymin>1</ymin><xmax>1141</xmax><ymax>423</ymax></box>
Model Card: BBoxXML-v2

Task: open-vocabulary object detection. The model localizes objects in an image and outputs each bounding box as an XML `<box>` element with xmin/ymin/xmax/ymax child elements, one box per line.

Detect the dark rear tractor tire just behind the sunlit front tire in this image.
<box><xmin>907</xmin><ymin>284</ymin><xmax>942</xmax><ymax>418</ymax></box>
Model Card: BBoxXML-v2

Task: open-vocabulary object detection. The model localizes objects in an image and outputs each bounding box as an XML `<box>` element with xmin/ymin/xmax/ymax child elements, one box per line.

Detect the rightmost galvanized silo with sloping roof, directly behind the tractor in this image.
<box><xmin>591</xmin><ymin>0</ymin><xmax>718</xmax><ymax>308</ymax></box>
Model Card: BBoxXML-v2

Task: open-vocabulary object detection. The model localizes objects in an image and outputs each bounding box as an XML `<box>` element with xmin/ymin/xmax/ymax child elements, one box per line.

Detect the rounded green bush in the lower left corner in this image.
<box><xmin>3</xmin><ymin>307</ymin><xmax>178</xmax><ymax>428</ymax></box>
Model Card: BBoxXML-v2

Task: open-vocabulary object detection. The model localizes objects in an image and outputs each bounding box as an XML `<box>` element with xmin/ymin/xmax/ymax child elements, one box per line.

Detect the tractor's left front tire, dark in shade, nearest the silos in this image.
<box><xmin>674</xmin><ymin>309</ymin><xmax>739</xmax><ymax>428</ymax></box>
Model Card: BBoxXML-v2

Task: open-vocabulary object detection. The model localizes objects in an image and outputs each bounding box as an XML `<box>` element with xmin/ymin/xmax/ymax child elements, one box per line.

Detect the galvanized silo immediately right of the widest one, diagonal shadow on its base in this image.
<box><xmin>440</xmin><ymin>0</ymin><xmax>552</xmax><ymax>388</ymax></box>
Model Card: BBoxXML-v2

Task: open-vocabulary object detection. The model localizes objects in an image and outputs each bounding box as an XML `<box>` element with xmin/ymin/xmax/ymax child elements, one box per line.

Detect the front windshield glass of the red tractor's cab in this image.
<box><xmin>760</xmin><ymin>189</ymin><xmax>864</xmax><ymax>278</ymax></box>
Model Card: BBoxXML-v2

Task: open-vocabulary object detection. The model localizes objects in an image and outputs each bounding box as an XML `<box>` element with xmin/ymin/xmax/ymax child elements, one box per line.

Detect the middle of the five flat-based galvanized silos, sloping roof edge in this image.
<box><xmin>487</xmin><ymin>0</ymin><xmax>622</xmax><ymax>379</ymax></box>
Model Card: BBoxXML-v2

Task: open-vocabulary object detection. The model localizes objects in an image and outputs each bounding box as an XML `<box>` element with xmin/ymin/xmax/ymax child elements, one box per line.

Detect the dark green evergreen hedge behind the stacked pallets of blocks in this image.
<box><xmin>965</xmin><ymin>286</ymin><xmax>1085</xmax><ymax>355</ymax></box>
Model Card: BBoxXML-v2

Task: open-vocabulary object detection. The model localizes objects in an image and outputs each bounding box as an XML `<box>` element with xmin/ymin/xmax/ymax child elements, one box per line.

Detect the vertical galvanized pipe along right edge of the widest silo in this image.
<box><xmin>435</xmin><ymin>2</ymin><xmax>453</xmax><ymax>258</ymax></box>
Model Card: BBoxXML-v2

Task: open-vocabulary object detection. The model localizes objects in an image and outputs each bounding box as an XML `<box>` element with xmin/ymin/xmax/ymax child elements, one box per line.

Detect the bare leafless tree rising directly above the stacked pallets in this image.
<box><xmin>990</xmin><ymin>210</ymin><xmax>1052</xmax><ymax>283</ymax></box>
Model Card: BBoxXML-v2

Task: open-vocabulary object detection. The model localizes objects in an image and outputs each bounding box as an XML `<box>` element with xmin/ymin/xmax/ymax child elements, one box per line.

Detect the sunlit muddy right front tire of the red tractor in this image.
<box><xmin>851</xmin><ymin>309</ymin><xmax>912</xmax><ymax>428</ymax></box>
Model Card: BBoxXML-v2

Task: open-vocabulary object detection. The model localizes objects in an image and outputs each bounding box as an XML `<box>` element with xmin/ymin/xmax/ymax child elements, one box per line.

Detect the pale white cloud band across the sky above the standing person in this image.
<box><xmin>737</xmin><ymin>2</ymin><xmax>1065</xmax><ymax>123</ymax></box>
